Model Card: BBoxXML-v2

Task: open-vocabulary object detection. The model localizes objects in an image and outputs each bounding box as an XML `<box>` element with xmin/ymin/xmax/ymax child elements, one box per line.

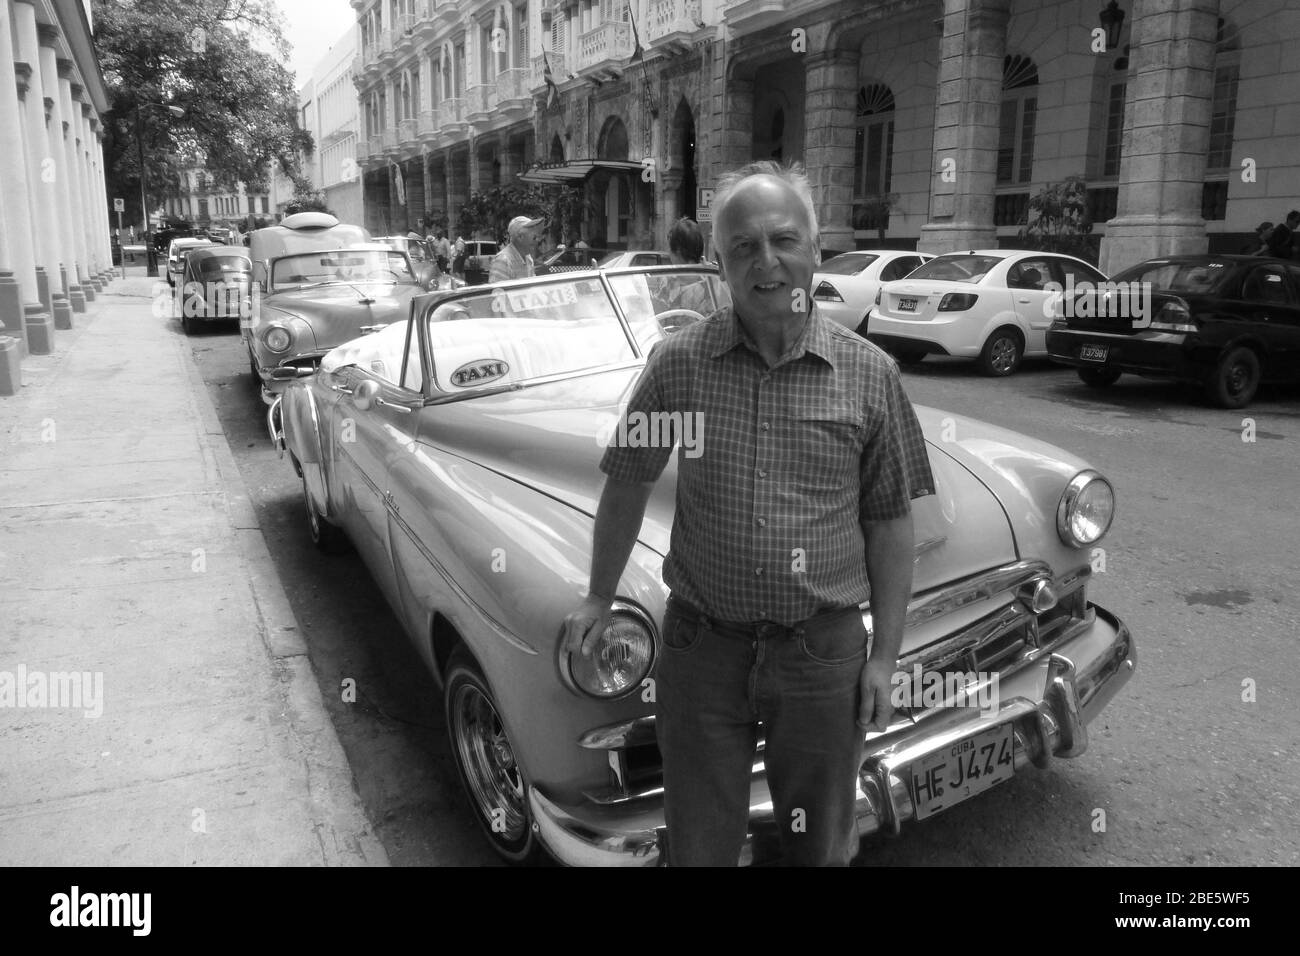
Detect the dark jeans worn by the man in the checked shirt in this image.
<box><xmin>655</xmin><ymin>600</ymin><xmax>867</xmax><ymax>866</ymax></box>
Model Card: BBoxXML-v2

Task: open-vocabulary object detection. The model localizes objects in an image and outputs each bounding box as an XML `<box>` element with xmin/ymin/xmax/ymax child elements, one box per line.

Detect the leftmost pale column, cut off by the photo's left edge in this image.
<box><xmin>0</xmin><ymin>1</ymin><xmax>49</xmax><ymax>355</ymax></box>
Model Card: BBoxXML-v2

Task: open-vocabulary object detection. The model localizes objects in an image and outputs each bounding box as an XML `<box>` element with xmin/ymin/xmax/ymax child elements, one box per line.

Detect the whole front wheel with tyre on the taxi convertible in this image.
<box><xmin>443</xmin><ymin>646</ymin><xmax>543</xmax><ymax>864</ymax></box>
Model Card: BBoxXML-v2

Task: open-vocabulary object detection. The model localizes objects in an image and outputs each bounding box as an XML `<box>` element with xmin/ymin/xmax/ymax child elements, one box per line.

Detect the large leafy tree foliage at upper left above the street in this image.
<box><xmin>94</xmin><ymin>0</ymin><xmax>313</xmax><ymax>227</ymax></box>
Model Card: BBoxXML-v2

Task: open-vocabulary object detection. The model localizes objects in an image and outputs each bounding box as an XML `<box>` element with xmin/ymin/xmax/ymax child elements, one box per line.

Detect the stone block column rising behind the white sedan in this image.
<box><xmin>919</xmin><ymin>0</ymin><xmax>1011</xmax><ymax>252</ymax></box>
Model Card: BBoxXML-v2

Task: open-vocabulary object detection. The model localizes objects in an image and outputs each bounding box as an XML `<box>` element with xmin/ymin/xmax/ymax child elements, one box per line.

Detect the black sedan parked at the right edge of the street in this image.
<box><xmin>1047</xmin><ymin>255</ymin><xmax>1300</xmax><ymax>408</ymax></box>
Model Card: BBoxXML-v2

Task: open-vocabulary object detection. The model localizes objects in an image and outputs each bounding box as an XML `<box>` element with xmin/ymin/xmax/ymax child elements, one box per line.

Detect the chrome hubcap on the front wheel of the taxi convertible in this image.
<box><xmin>451</xmin><ymin>685</ymin><xmax>528</xmax><ymax>842</ymax></box>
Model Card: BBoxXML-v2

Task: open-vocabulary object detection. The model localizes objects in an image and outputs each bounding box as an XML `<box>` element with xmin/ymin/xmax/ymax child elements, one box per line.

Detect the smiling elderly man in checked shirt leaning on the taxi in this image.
<box><xmin>564</xmin><ymin>161</ymin><xmax>933</xmax><ymax>866</ymax></box>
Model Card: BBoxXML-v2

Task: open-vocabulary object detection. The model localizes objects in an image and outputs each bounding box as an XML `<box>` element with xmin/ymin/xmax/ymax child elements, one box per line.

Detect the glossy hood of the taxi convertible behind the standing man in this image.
<box><xmin>421</xmin><ymin>367</ymin><xmax>1024</xmax><ymax>591</ymax></box>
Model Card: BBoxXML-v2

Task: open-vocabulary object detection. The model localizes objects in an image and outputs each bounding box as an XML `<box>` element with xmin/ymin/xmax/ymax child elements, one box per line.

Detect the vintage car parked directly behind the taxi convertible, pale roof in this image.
<box><xmin>239</xmin><ymin>212</ymin><xmax>437</xmax><ymax>403</ymax></box>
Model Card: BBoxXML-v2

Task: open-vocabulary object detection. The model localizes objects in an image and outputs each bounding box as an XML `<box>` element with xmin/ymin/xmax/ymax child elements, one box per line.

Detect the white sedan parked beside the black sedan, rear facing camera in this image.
<box><xmin>863</xmin><ymin>248</ymin><xmax>1106</xmax><ymax>376</ymax></box>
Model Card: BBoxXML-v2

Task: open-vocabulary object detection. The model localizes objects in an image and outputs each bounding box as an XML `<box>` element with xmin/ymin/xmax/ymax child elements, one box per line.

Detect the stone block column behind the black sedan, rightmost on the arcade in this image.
<box><xmin>1101</xmin><ymin>0</ymin><xmax>1219</xmax><ymax>274</ymax></box>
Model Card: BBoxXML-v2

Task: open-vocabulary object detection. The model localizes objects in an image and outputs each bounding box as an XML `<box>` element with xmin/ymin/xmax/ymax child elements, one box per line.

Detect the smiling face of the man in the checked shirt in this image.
<box><xmin>714</xmin><ymin>176</ymin><xmax>820</xmax><ymax>329</ymax></box>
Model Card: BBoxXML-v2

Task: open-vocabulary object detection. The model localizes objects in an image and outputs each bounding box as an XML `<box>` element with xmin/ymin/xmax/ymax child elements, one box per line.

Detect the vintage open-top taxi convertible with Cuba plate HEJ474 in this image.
<box><xmin>268</xmin><ymin>267</ymin><xmax>1136</xmax><ymax>865</ymax></box>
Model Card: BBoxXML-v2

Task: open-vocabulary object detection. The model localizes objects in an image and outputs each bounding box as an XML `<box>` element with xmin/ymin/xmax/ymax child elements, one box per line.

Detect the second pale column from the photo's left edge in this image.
<box><xmin>10</xmin><ymin>0</ymin><xmax>72</xmax><ymax>329</ymax></box>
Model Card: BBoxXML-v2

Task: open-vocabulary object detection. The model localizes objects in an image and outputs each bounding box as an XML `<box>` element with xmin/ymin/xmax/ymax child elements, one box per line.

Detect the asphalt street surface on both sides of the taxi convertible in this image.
<box><xmin>185</xmin><ymin>297</ymin><xmax>1300</xmax><ymax>865</ymax></box>
